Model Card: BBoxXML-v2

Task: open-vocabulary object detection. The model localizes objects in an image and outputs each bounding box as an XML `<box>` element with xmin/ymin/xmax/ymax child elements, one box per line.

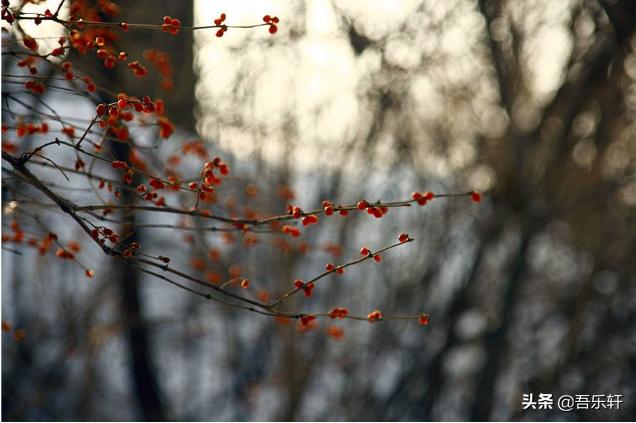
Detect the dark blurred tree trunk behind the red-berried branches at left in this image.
<box><xmin>72</xmin><ymin>0</ymin><xmax>195</xmax><ymax>421</ymax></box>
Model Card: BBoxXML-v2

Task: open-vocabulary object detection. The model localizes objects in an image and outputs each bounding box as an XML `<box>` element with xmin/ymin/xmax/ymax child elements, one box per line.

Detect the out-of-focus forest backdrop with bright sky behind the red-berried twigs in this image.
<box><xmin>2</xmin><ymin>0</ymin><xmax>636</xmax><ymax>421</ymax></box>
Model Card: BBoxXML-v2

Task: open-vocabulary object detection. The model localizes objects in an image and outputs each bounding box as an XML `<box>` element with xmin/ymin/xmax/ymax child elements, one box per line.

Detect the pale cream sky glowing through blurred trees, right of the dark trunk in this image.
<box><xmin>195</xmin><ymin>0</ymin><xmax>570</xmax><ymax>181</ymax></box>
